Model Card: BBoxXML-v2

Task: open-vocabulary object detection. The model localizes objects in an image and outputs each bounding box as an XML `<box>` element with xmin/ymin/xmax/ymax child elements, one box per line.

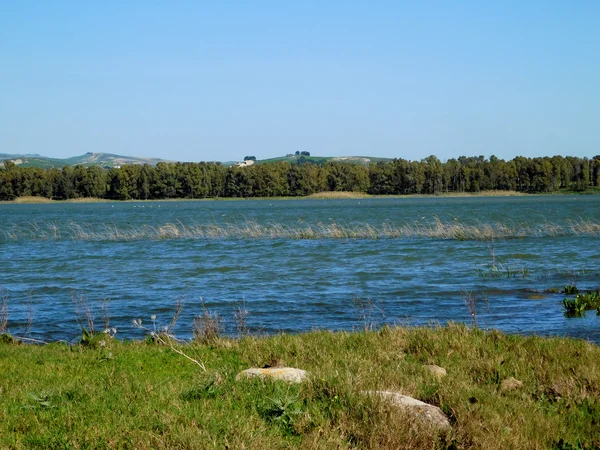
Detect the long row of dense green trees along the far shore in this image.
<box><xmin>0</xmin><ymin>156</ymin><xmax>600</xmax><ymax>200</ymax></box>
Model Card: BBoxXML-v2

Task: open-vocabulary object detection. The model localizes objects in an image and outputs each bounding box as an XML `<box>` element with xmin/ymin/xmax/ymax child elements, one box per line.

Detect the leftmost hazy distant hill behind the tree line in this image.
<box><xmin>0</xmin><ymin>152</ymin><xmax>172</xmax><ymax>169</ymax></box>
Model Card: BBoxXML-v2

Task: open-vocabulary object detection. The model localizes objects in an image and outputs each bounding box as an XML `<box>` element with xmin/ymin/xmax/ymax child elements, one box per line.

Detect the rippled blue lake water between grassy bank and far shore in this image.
<box><xmin>0</xmin><ymin>196</ymin><xmax>600</xmax><ymax>342</ymax></box>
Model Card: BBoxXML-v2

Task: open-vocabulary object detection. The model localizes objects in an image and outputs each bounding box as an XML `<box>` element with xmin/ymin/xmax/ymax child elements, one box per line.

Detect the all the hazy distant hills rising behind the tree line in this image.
<box><xmin>0</xmin><ymin>152</ymin><xmax>391</xmax><ymax>169</ymax></box>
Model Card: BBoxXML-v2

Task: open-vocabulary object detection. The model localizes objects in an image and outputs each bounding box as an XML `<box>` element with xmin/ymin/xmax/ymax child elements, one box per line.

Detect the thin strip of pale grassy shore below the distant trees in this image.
<box><xmin>0</xmin><ymin>189</ymin><xmax>600</xmax><ymax>205</ymax></box>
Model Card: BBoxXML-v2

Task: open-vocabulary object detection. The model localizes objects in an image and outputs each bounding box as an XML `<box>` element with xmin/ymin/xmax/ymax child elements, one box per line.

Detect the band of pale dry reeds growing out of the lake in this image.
<box><xmin>0</xmin><ymin>217</ymin><xmax>600</xmax><ymax>242</ymax></box>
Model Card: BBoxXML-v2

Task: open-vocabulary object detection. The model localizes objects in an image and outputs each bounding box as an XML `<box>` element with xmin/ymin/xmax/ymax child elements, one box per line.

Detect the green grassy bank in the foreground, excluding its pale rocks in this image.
<box><xmin>0</xmin><ymin>325</ymin><xmax>600</xmax><ymax>449</ymax></box>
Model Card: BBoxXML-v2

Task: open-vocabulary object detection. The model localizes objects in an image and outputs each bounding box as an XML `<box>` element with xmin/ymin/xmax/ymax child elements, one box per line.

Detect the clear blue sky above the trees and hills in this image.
<box><xmin>0</xmin><ymin>0</ymin><xmax>600</xmax><ymax>161</ymax></box>
